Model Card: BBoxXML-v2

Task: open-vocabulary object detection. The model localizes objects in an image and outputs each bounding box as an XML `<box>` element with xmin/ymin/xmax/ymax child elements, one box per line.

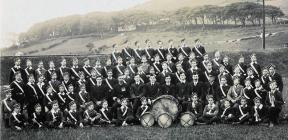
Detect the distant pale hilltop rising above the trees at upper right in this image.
<box><xmin>130</xmin><ymin>0</ymin><xmax>288</xmax><ymax>14</ymax></box>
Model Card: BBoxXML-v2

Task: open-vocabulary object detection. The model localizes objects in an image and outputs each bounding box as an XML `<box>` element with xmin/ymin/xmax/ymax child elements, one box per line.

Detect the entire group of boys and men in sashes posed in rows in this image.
<box><xmin>2</xmin><ymin>39</ymin><xmax>284</xmax><ymax>130</ymax></box>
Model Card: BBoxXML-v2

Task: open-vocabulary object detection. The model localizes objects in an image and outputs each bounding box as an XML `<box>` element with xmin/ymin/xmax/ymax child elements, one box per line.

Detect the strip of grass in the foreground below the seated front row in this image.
<box><xmin>2</xmin><ymin>124</ymin><xmax>288</xmax><ymax>140</ymax></box>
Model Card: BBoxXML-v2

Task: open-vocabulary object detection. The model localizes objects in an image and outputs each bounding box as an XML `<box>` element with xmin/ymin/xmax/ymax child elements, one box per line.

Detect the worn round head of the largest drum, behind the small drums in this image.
<box><xmin>151</xmin><ymin>95</ymin><xmax>179</xmax><ymax>120</ymax></box>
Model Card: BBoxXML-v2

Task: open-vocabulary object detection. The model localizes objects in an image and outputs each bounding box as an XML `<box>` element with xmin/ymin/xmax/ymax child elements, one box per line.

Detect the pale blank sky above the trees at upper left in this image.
<box><xmin>0</xmin><ymin>0</ymin><xmax>147</xmax><ymax>35</ymax></box>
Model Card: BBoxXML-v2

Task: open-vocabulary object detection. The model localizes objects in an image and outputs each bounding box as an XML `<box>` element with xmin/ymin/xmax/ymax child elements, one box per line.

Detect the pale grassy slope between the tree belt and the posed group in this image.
<box><xmin>1</xmin><ymin>25</ymin><xmax>288</xmax><ymax>56</ymax></box>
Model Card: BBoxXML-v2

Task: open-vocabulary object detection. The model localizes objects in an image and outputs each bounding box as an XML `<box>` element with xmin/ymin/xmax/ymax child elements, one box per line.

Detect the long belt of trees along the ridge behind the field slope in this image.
<box><xmin>19</xmin><ymin>2</ymin><xmax>284</xmax><ymax>42</ymax></box>
